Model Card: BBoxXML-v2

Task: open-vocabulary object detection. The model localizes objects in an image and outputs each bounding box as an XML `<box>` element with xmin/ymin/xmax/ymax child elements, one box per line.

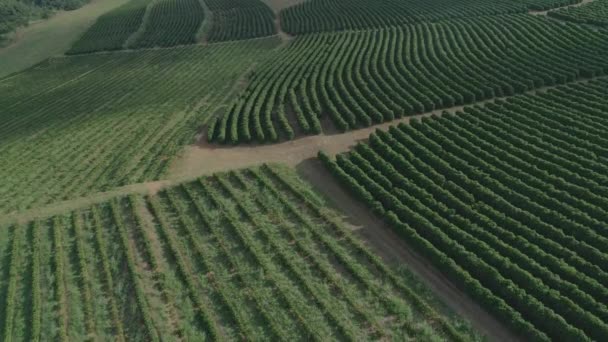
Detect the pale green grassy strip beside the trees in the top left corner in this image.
<box><xmin>0</xmin><ymin>0</ymin><xmax>129</xmax><ymax>77</ymax></box>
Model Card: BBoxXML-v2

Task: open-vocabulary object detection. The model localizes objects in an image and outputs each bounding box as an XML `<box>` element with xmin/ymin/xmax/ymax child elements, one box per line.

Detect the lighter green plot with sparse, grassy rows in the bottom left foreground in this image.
<box><xmin>0</xmin><ymin>166</ymin><xmax>478</xmax><ymax>341</ymax></box>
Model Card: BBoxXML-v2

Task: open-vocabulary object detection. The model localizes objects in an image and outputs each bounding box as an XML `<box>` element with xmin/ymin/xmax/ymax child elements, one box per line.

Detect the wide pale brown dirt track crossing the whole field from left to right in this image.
<box><xmin>0</xmin><ymin>79</ymin><xmax>590</xmax><ymax>225</ymax></box>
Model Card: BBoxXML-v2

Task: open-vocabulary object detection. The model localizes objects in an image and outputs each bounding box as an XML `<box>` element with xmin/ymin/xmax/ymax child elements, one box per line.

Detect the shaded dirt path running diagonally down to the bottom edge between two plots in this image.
<box><xmin>296</xmin><ymin>159</ymin><xmax>520</xmax><ymax>341</ymax></box>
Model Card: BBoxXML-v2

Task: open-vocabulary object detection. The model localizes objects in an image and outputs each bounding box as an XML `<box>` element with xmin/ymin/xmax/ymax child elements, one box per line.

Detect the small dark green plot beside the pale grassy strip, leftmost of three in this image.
<box><xmin>67</xmin><ymin>0</ymin><xmax>150</xmax><ymax>54</ymax></box>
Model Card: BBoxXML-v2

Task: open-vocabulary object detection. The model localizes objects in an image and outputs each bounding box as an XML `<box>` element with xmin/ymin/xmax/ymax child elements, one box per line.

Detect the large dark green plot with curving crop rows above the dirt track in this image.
<box><xmin>207</xmin><ymin>15</ymin><xmax>608</xmax><ymax>144</ymax></box>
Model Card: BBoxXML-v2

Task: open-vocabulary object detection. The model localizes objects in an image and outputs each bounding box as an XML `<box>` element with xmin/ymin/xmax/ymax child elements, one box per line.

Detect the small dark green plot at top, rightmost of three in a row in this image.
<box><xmin>206</xmin><ymin>0</ymin><xmax>277</xmax><ymax>42</ymax></box>
